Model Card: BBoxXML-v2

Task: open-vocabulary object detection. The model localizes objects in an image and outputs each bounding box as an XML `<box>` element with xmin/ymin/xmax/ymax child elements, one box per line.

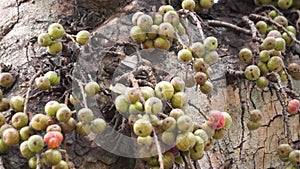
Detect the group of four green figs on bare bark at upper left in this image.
<box><xmin>37</xmin><ymin>23</ymin><xmax>90</xmax><ymax>55</ymax></box>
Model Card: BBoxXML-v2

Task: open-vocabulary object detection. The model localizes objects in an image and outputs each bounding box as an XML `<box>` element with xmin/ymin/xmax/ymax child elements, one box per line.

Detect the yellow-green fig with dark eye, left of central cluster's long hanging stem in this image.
<box><xmin>133</xmin><ymin>119</ymin><xmax>152</xmax><ymax>137</ymax></box>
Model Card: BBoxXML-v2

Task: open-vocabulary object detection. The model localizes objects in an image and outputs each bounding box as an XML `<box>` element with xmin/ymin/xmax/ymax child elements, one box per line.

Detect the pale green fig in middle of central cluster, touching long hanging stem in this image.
<box><xmin>145</xmin><ymin>97</ymin><xmax>163</xmax><ymax>114</ymax></box>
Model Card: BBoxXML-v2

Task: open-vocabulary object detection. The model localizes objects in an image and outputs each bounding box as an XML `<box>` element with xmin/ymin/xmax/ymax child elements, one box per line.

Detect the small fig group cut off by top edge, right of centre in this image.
<box><xmin>181</xmin><ymin>0</ymin><xmax>214</xmax><ymax>12</ymax></box>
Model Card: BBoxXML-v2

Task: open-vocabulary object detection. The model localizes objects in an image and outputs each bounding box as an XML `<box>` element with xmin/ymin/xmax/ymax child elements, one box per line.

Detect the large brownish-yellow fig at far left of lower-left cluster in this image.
<box><xmin>2</xmin><ymin>128</ymin><xmax>20</xmax><ymax>146</ymax></box>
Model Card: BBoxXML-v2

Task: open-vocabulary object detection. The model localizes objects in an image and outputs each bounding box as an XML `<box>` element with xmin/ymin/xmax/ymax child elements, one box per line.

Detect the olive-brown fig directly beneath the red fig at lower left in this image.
<box><xmin>42</xmin><ymin>149</ymin><xmax>62</xmax><ymax>166</ymax></box>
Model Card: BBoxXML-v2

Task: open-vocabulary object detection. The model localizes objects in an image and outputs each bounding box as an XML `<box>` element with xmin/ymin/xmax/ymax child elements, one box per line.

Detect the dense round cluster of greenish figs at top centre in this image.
<box><xmin>130</xmin><ymin>5</ymin><xmax>185</xmax><ymax>50</ymax></box>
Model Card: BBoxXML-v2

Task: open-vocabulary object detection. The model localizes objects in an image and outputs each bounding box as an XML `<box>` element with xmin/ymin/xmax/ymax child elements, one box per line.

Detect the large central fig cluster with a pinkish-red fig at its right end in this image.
<box><xmin>115</xmin><ymin>77</ymin><xmax>232</xmax><ymax>168</ymax></box>
